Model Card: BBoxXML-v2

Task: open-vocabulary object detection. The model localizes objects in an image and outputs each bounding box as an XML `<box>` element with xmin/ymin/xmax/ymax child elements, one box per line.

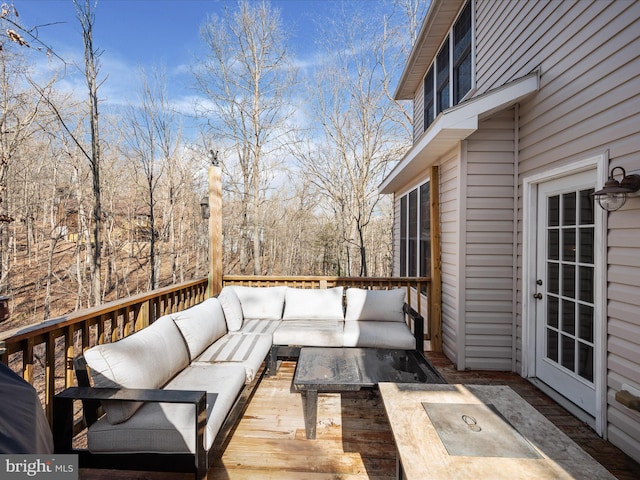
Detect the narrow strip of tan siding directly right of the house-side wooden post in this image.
<box><xmin>440</xmin><ymin>154</ymin><xmax>460</xmax><ymax>363</ymax></box>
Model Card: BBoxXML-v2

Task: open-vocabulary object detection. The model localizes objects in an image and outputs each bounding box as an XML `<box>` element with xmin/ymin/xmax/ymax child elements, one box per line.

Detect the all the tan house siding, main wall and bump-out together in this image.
<box><xmin>392</xmin><ymin>0</ymin><xmax>640</xmax><ymax>461</ymax></box>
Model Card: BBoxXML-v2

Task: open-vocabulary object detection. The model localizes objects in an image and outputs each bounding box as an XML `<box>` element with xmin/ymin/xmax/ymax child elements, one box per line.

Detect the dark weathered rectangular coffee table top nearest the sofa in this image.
<box><xmin>293</xmin><ymin>347</ymin><xmax>446</xmax><ymax>392</ymax></box>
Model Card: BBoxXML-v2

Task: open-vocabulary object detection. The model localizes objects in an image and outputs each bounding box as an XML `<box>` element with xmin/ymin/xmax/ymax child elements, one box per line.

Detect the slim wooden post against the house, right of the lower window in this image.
<box><xmin>429</xmin><ymin>165</ymin><xmax>442</xmax><ymax>352</ymax></box>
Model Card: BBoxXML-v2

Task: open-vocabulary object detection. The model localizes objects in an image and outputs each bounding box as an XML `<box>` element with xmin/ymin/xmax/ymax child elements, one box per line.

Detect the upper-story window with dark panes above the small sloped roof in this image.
<box><xmin>424</xmin><ymin>2</ymin><xmax>473</xmax><ymax>130</ymax></box>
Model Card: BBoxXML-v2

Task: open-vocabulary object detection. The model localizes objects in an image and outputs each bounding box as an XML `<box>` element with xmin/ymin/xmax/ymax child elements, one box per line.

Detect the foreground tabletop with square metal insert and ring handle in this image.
<box><xmin>378</xmin><ymin>383</ymin><xmax>614</xmax><ymax>480</ymax></box>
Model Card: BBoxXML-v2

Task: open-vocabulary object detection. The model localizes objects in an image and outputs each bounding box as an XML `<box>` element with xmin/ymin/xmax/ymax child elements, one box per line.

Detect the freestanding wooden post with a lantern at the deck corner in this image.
<box><xmin>207</xmin><ymin>162</ymin><xmax>222</xmax><ymax>297</ymax></box>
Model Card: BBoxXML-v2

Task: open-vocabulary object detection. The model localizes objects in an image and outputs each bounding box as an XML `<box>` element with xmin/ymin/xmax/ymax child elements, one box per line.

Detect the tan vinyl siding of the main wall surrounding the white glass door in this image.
<box><xmin>467</xmin><ymin>0</ymin><xmax>640</xmax><ymax>460</ymax></box>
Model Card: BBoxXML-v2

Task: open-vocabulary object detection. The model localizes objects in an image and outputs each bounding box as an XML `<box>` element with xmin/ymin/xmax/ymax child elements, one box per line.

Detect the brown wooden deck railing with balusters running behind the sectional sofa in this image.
<box><xmin>0</xmin><ymin>275</ymin><xmax>433</xmax><ymax>423</ymax></box>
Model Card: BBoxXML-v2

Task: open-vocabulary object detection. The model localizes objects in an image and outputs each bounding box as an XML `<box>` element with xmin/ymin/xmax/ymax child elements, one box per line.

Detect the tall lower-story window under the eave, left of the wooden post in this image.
<box><xmin>399</xmin><ymin>182</ymin><xmax>431</xmax><ymax>277</ymax></box>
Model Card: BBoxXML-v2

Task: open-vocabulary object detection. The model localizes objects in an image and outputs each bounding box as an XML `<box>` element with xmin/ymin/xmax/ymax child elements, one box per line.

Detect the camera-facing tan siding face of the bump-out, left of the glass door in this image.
<box><xmin>462</xmin><ymin>110</ymin><xmax>515</xmax><ymax>370</ymax></box>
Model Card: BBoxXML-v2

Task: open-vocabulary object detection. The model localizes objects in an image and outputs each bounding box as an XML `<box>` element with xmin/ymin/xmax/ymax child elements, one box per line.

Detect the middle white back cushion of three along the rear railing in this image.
<box><xmin>282</xmin><ymin>287</ymin><xmax>344</xmax><ymax>320</ymax></box>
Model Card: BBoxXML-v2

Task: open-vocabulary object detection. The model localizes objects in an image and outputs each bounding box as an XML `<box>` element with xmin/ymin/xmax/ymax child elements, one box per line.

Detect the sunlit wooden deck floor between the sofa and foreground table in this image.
<box><xmin>209</xmin><ymin>362</ymin><xmax>396</xmax><ymax>480</ymax></box>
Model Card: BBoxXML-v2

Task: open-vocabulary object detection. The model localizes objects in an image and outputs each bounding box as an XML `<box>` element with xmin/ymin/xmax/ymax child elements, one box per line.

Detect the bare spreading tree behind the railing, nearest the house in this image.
<box><xmin>297</xmin><ymin>0</ymin><xmax>424</xmax><ymax>276</ymax></box>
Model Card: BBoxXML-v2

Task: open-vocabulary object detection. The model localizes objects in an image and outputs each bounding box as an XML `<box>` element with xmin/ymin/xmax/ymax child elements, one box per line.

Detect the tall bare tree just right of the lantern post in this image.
<box><xmin>194</xmin><ymin>1</ymin><xmax>297</xmax><ymax>274</ymax></box>
